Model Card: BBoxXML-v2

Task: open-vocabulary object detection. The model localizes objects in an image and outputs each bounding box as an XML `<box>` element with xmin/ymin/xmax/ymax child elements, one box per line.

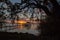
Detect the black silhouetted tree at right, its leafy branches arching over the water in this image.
<box><xmin>0</xmin><ymin>0</ymin><xmax>60</xmax><ymax>40</ymax></box>
